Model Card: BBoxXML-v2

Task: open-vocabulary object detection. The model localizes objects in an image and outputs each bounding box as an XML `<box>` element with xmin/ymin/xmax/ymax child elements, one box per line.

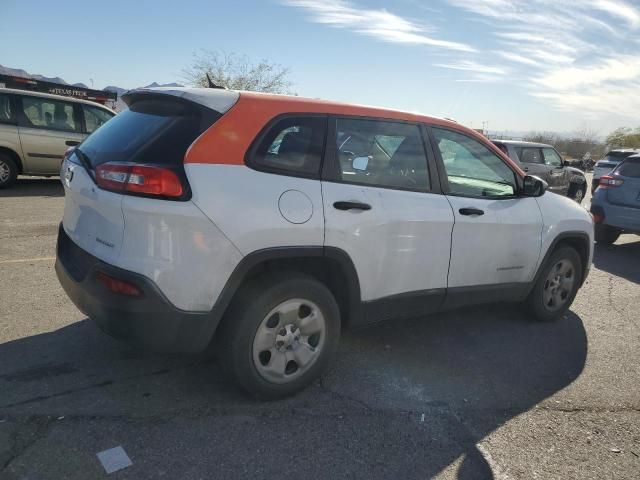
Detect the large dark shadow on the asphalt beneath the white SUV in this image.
<box><xmin>0</xmin><ymin>307</ymin><xmax>587</xmax><ymax>479</ymax></box>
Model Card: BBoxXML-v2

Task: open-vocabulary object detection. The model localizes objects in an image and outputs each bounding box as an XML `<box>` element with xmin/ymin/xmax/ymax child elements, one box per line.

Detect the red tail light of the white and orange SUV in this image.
<box><xmin>96</xmin><ymin>162</ymin><xmax>184</xmax><ymax>198</ymax></box>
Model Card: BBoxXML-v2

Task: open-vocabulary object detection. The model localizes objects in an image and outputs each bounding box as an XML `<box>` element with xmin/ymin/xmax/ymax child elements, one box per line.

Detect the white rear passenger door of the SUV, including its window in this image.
<box><xmin>322</xmin><ymin>118</ymin><xmax>453</xmax><ymax>323</ymax></box>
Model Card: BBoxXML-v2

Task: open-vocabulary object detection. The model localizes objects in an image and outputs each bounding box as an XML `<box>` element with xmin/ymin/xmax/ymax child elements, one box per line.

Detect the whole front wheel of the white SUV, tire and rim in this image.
<box><xmin>526</xmin><ymin>247</ymin><xmax>582</xmax><ymax>321</ymax></box>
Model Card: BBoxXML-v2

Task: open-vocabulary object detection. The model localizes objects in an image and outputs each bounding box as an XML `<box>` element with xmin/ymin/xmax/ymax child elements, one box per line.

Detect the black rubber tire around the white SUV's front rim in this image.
<box><xmin>525</xmin><ymin>246</ymin><xmax>583</xmax><ymax>322</ymax></box>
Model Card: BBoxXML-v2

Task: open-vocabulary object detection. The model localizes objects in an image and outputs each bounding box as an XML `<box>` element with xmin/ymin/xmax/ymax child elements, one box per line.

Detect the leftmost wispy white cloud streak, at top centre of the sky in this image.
<box><xmin>285</xmin><ymin>0</ymin><xmax>475</xmax><ymax>52</ymax></box>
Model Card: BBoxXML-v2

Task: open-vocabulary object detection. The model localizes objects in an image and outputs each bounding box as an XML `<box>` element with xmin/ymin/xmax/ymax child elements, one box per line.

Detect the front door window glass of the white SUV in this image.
<box><xmin>432</xmin><ymin>128</ymin><xmax>517</xmax><ymax>198</ymax></box>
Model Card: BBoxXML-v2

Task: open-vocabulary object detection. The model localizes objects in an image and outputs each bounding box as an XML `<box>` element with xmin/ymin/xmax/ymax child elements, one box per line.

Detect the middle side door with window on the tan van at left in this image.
<box><xmin>18</xmin><ymin>95</ymin><xmax>85</xmax><ymax>175</ymax></box>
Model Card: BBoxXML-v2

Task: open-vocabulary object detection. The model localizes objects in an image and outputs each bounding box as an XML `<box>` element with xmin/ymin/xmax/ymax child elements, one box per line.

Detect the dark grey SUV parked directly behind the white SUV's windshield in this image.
<box><xmin>492</xmin><ymin>140</ymin><xmax>587</xmax><ymax>203</ymax></box>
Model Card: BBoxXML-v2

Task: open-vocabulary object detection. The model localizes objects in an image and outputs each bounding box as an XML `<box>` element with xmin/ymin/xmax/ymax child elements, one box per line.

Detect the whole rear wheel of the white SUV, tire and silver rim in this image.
<box><xmin>218</xmin><ymin>274</ymin><xmax>340</xmax><ymax>399</ymax></box>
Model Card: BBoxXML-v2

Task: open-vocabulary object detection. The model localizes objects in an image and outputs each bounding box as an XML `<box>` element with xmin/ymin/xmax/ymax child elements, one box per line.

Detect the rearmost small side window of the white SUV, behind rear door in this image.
<box><xmin>247</xmin><ymin>116</ymin><xmax>327</xmax><ymax>176</ymax></box>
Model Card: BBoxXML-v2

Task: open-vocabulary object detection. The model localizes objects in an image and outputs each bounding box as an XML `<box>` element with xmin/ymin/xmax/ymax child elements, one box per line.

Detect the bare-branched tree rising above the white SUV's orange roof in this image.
<box><xmin>182</xmin><ymin>50</ymin><xmax>292</xmax><ymax>93</ymax></box>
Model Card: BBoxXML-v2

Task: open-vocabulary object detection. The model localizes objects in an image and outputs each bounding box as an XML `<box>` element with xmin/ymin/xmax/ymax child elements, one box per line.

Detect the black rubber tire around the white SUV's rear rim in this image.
<box><xmin>216</xmin><ymin>273</ymin><xmax>340</xmax><ymax>399</ymax></box>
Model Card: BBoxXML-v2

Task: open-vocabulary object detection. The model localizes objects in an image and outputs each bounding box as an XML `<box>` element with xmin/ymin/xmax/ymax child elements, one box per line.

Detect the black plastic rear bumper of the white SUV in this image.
<box><xmin>55</xmin><ymin>225</ymin><xmax>219</xmax><ymax>353</ymax></box>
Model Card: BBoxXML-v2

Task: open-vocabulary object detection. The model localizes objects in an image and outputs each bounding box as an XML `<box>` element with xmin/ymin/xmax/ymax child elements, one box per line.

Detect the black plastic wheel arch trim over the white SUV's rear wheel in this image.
<box><xmin>213</xmin><ymin>246</ymin><xmax>361</xmax><ymax>334</ymax></box>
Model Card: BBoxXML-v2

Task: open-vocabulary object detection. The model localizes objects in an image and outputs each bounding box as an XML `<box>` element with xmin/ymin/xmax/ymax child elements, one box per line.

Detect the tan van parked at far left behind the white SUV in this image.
<box><xmin>0</xmin><ymin>88</ymin><xmax>115</xmax><ymax>188</ymax></box>
